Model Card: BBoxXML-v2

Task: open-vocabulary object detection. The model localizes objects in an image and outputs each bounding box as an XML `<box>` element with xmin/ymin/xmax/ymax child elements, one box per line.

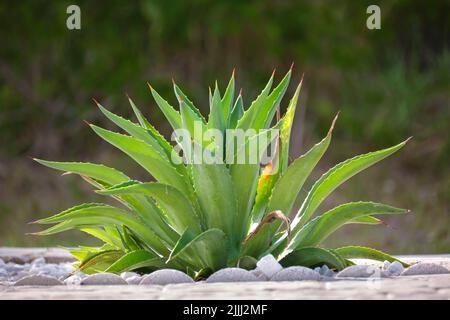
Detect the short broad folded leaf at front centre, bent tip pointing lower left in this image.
<box><xmin>169</xmin><ymin>229</ymin><xmax>228</xmax><ymax>270</ymax></box>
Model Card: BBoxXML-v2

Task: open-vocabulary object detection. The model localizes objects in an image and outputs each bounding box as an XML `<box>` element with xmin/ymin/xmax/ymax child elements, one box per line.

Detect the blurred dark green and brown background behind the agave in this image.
<box><xmin>0</xmin><ymin>0</ymin><xmax>450</xmax><ymax>254</ymax></box>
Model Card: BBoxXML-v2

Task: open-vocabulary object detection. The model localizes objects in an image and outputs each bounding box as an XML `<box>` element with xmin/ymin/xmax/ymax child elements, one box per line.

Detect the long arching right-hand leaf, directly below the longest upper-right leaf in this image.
<box><xmin>284</xmin><ymin>202</ymin><xmax>408</xmax><ymax>255</ymax></box>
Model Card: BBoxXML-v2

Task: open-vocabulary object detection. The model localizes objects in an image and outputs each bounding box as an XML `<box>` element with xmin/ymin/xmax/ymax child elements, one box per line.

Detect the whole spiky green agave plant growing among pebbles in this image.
<box><xmin>35</xmin><ymin>70</ymin><xmax>407</xmax><ymax>279</ymax></box>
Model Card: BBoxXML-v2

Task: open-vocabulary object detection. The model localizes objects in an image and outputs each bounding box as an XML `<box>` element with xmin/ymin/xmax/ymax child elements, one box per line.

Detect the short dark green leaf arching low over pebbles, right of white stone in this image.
<box><xmin>280</xmin><ymin>247</ymin><xmax>346</xmax><ymax>270</ymax></box>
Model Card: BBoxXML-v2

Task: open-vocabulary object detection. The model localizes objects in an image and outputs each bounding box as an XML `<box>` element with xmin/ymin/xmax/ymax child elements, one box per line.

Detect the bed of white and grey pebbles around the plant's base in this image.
<box><xmin>0</xmin><ymin>255</ymin><xmax>450</xmax><ymax>287</ymax></box>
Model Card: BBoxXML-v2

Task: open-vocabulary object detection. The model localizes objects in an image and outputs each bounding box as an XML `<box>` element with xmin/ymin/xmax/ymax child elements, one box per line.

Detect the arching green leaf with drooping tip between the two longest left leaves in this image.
<box><xmin>97</xmin><ymin>182</ymin><xmax>200</xmax><ymax>234</ymax></box>
